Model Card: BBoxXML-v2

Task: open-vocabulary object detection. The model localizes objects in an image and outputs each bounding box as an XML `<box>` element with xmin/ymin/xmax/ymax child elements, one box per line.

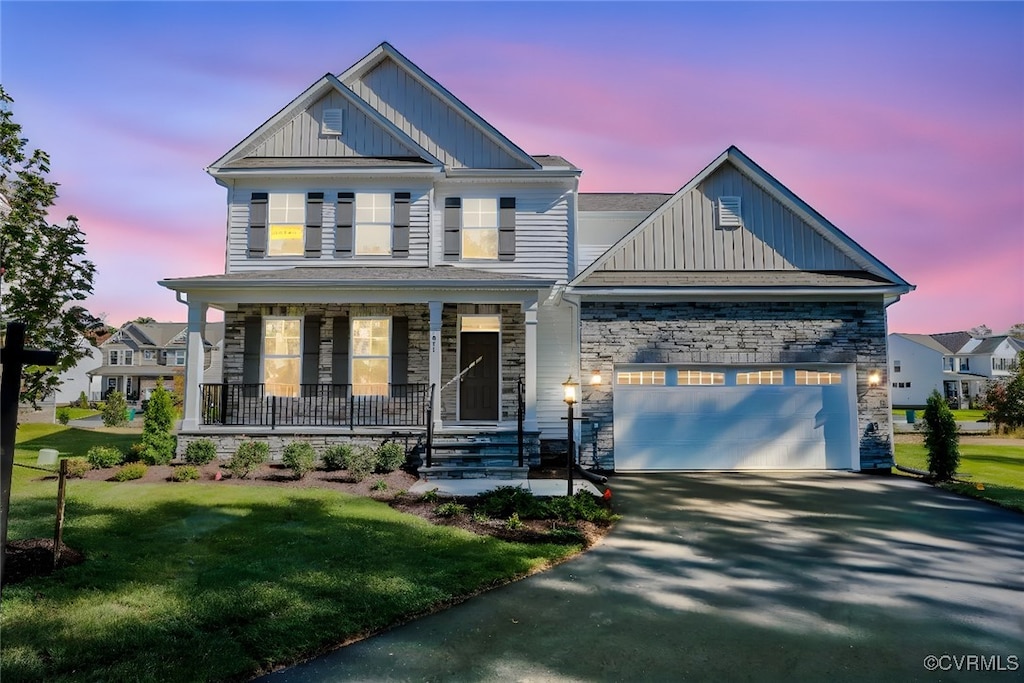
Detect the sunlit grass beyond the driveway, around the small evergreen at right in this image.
<box><xmin>896</xmin><ymin>439</ymin><xmax>1024</xmax><ymax>512</ymax></box>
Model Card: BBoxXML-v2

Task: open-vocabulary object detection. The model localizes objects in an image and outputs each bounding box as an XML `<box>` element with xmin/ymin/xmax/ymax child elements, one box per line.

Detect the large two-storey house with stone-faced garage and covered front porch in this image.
<box><xmin>161</xmin><ymin>43</ymin><xmax>913</xmax><ymax>476</ymax></box>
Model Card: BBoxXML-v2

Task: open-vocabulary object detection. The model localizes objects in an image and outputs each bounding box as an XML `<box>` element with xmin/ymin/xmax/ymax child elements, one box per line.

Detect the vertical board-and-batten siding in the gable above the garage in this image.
<box><xmin>599</xmin><ymin>164</ymin><xmax>861</xmax><ymax>270</ymax></box>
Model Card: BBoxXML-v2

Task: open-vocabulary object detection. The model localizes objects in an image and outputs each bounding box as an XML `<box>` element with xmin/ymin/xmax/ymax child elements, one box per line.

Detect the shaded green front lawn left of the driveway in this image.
<box><xmin>0</xmin><ymin>425</ymin><xmax>579</xmax><ymax>683</ymax></box>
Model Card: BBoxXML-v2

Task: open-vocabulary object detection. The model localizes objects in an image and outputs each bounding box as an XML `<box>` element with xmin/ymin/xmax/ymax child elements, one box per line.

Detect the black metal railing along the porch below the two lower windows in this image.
<box><xmin>200</xmin><ymin>384</ymin><xmax>431</xmax><ymax>428</ymax></box>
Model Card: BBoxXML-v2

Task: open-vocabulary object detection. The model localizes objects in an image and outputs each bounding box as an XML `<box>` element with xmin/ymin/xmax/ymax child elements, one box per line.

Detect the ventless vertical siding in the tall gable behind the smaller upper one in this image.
<box><xmin>351</xmin><ymin>59</ymin><xmax>529</xmax><ymax>168</ymax></box>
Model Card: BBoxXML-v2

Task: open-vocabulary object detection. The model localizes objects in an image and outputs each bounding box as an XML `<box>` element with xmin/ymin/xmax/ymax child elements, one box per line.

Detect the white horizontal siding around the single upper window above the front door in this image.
<box><xmin>432</xmin><ymin>185</ymin><xmax>570</xmax><ymax>280</ymax></box>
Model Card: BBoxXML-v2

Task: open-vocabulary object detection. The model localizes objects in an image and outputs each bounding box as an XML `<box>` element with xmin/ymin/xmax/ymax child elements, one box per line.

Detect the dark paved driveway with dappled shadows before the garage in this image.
<box><xmin>260</xmin><ymin>473</ymin><xmax>1024</xmax><ymax>681</ymax></box>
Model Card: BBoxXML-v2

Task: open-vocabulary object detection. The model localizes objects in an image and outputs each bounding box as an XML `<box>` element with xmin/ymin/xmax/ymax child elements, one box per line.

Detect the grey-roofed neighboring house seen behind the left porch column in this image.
<box><xmin>91</xmin><ymin>323</ymin><xmax>224</xmax><ymax>400</ymax></box>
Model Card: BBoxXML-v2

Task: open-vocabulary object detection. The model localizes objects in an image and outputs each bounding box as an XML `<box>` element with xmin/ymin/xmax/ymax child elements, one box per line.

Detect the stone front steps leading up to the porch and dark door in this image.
<box><xmin>419</xmin><ymin>427</ymin><xmax>541</xmax><ymax>480</ymax></box>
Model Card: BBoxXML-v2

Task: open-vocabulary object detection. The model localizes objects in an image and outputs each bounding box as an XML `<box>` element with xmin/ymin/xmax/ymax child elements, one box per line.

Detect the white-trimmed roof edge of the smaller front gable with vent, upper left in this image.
<box><xmin>207</xmin><ymin>74</ymin><xmax>443</xmax><ymax>175</ymax></box>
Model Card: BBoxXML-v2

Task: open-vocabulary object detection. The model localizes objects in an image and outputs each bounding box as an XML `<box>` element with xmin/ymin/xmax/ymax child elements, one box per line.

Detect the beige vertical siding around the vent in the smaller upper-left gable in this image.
<box><xmin>246</xmin><ymin>92</ymin><xmax>420</xmax><ymax>157</ymax></box>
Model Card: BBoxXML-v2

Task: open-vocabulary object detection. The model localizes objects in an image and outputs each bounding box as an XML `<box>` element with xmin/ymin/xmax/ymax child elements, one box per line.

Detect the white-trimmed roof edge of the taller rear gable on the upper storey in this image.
<box><xmin>338</xmin><ymin>42</ymin><xmax>541</xmax><ymax>170</ymax></box>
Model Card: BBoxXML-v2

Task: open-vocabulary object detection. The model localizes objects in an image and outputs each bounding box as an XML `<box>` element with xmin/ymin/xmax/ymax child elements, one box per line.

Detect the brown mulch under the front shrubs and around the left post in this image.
<box><xmin>3</xmin><ymin>464</ymin><xmax>610</xmax><ymax>585</ymax></box>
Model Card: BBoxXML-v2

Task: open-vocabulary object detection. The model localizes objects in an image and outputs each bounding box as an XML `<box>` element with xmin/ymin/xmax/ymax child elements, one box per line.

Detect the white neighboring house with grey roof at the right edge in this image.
<box><xmin>889</xmin><ymin>332</ymin><xmax>1024</xmax><ymax>408</ymax></box>
